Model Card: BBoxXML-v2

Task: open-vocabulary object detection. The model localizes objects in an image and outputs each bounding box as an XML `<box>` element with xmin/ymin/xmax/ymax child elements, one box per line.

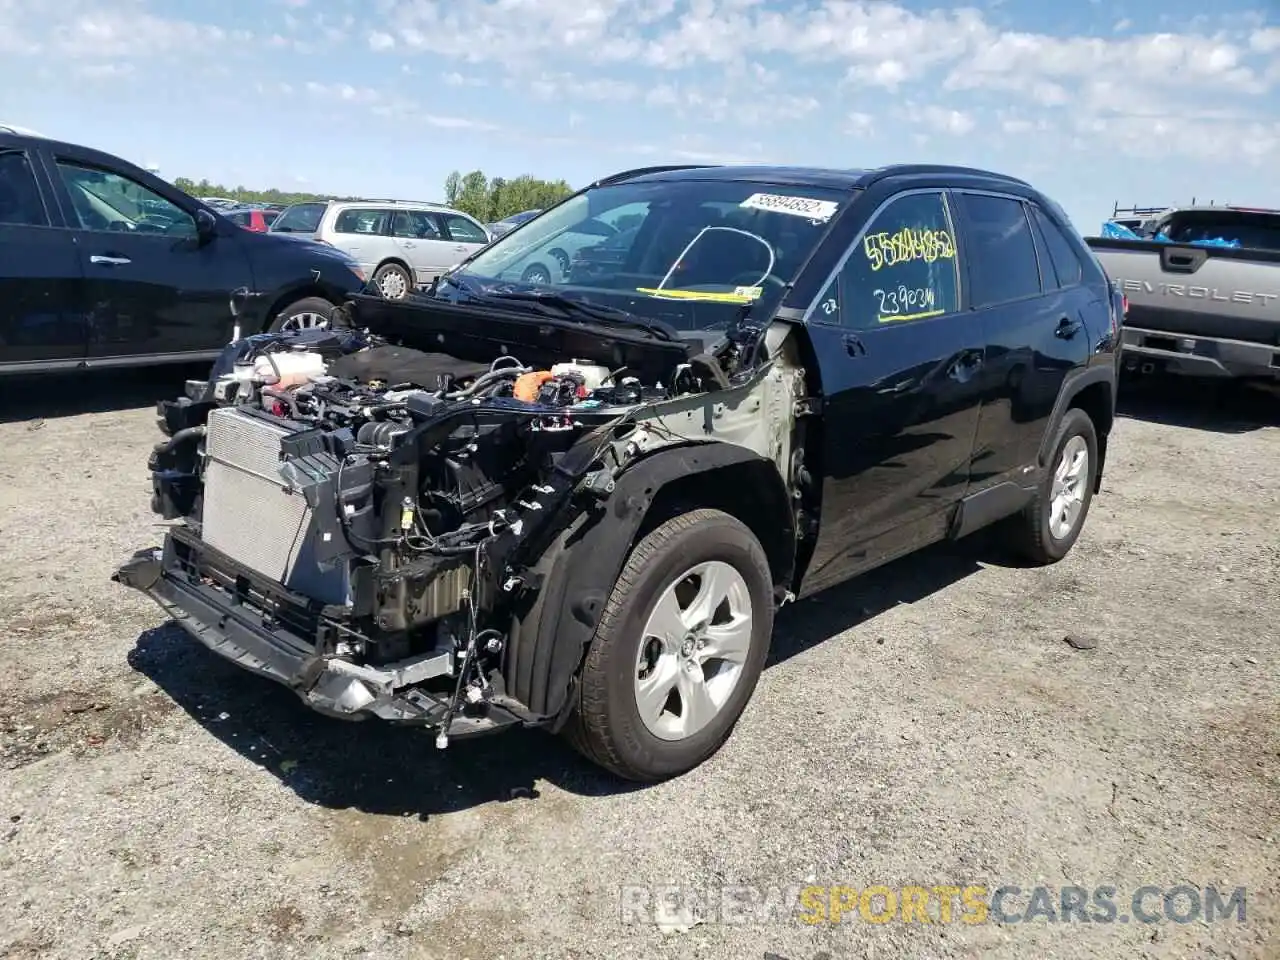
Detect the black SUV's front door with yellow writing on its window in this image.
<box><xmin>803</xmin><ymin>189</ymin><xmax>986</xmax><ymax>595</ymax></box>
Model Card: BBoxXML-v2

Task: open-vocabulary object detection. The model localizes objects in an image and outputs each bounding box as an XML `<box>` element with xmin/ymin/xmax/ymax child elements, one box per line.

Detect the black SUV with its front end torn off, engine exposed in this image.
<box><xmin>115</xmin><ymin>165</ymin><xmax>1123</xmax><ymax>781</ymax></box>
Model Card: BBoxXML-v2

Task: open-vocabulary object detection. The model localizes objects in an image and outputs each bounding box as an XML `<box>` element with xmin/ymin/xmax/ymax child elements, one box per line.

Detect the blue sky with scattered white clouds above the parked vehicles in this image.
<box><xmin>0</xmin><ymin>0</ymin><xmax>1280</xmax><ymax>183</ymax></box>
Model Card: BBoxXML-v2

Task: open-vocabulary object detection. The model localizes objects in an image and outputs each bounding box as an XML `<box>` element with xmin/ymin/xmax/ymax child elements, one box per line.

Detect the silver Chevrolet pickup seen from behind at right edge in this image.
<box><xmin>1087</xmin><ymin>206</ymin><xmax>1280</xmax><ymax>384</ymax></box>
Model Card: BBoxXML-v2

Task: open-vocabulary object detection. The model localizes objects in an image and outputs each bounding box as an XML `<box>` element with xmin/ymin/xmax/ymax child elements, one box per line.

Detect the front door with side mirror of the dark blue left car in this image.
<box><xmin>52</xmin><ymin>156</ymin><xmax>253</xmax><ymax>360</ymax></box>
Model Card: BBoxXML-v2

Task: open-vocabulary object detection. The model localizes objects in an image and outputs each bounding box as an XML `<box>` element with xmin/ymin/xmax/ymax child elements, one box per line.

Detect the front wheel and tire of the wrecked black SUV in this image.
<box><xmin>564</xmin><ymin>509</ymin><xmax>773</xmax><ymax>783</ymax></box>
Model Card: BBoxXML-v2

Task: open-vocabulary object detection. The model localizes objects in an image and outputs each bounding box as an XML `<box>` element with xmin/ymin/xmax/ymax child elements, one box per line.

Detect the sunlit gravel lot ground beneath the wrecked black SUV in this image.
<box><xmin>0</xmin><ymin>371</ymin><xmax>1280</xmax><ymax>960</ymax></box>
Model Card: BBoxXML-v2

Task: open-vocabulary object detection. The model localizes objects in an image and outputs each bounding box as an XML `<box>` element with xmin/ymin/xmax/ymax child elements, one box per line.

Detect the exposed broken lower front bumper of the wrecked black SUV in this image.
<box><xmin>111</xmin><ymin>527</ymin><xmax>521</xmax><ymax>739</ymax></box>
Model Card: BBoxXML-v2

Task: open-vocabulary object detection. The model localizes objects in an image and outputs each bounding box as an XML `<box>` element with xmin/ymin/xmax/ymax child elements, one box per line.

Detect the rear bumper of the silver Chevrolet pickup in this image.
<box><xmin>1121</xmin><ymin>326</ymin><xmax>1280</xmax><ymax>380</ymax></box>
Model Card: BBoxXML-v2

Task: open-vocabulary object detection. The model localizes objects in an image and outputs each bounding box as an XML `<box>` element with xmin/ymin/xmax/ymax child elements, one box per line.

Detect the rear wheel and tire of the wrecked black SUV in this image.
<box><xmin>1010</xmin><ymin>407</ymin><xmax>1098</xmax><ymax>566</ymax></box>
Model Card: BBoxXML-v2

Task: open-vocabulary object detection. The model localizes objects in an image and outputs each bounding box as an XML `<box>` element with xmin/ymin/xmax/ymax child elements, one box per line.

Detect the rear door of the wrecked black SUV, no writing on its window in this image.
<box><xmin>955</xmin><ymin>191</ymin><xmax>1094</xmax><ymax>483</ymax></box>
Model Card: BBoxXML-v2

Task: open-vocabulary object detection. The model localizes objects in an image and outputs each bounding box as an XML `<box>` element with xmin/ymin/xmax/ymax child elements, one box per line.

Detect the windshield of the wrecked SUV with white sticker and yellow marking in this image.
<box><xmin>454</xmin><ymin>179</ymin><xmax>851</xmax><ymax>329</ymax></box>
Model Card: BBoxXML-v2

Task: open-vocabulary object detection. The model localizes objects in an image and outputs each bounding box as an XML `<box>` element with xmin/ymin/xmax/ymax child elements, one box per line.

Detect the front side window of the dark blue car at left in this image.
<box><xmin>58</xmin><ymin>160</ymin><xmax>196</xmax><ymax>237</ymax></box>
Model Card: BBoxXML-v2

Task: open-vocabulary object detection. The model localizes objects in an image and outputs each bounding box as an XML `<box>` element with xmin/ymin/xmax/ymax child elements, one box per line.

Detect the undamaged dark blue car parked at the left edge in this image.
<box><xmin>0</xmin><ymin>128</ymin><xmax>365</xmax><ymax>375</ymax></box>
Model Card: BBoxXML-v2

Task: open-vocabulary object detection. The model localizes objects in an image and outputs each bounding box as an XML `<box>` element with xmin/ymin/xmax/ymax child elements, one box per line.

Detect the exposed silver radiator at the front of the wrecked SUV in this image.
<box><xmin>201</xmin><ymin>407</ymin><xmax>349</xmax><ymax>604</ymax></box>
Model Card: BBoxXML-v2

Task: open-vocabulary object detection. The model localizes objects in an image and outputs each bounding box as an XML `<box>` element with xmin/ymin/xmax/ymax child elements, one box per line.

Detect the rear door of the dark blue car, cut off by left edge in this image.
<box><xmin>0</xmin><ymin>137</ymin><xmax>87</xmax><ymax>369</ymax></box>
